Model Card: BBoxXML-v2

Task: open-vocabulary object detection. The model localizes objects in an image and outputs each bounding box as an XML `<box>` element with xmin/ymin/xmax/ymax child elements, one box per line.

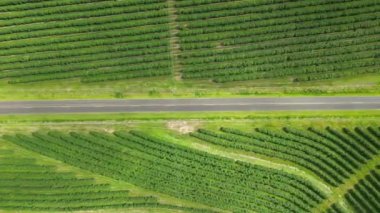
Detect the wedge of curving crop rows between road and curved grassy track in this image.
<box><xmin>191</xmin><ymin>127</ymin><xmax>379</xmax><ymax>186</ymax></box>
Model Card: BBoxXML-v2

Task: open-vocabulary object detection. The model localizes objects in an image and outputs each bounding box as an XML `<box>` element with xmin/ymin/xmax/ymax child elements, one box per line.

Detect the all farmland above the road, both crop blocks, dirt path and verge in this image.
<box><xmin>0</xmin><ymin>0</ymin><xmax>380</xmax><ymax>100</ymax></box>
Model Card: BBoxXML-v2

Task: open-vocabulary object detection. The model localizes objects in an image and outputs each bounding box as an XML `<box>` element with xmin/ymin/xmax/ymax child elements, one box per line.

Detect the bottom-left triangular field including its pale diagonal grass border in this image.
<box><xmin>0</xmin><ymin>141</ymin><xmax>220</xmax><ymax>212</ymax></box>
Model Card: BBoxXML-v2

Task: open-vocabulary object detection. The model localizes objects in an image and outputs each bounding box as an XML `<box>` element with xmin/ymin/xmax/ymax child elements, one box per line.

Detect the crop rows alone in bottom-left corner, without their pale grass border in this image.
<box><xmin>0</xmin><ymin>151</ymin><xmax>162</xmax><ymax>211</ymax></box>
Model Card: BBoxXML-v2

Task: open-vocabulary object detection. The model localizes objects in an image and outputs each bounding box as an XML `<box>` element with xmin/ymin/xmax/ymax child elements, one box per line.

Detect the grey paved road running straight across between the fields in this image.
<box><xmin>0</xmin><ymin>97</ymin><xmax>380</xmax><ymax>114</ymax></box>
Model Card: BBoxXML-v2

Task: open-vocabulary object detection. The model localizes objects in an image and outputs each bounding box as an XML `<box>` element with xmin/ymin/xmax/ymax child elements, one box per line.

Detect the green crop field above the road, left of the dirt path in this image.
<box><xmin>0</xmin><ymin>0</ymin><xmax>171</xmax><ymax>83</ymax></box>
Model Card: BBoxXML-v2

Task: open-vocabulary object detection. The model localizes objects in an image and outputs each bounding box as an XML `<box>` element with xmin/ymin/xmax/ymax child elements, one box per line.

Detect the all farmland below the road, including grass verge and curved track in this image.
<box><xmin>0</xmin><ymin>110</ymin><xmax>380</xmax><ymax>212</ymax></box>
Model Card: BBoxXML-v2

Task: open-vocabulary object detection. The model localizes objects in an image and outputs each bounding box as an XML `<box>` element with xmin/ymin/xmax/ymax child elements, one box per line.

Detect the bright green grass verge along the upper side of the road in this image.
<box><xmin>0</xmin><ymin>74</ymin><xmax>380</xmax><ymax>100</ymax></box>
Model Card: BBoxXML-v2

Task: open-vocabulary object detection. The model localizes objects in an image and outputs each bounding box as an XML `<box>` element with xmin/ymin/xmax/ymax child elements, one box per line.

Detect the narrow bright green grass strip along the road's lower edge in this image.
<box><xmin>0</xmin><ymin>110</ymin><xmax>380</xmax><ymax>125</ymax></box>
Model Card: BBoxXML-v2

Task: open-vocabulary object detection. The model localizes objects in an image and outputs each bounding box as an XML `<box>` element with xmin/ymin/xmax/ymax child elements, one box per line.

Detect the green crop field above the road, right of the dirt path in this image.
<box><xmin>176</xmin><ymin>0</ymin><xmax>380</xmax><ymax>82</ymax></box>
